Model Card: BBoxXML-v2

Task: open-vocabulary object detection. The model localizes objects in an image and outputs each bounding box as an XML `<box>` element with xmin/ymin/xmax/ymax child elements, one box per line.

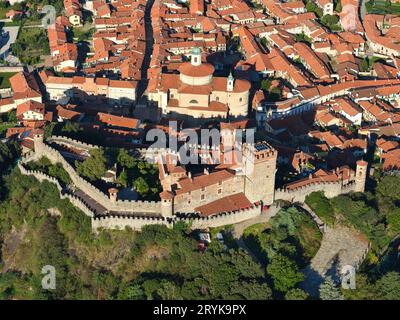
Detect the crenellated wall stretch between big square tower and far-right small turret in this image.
<box><xmin>275</xmin><ymin>181</ymin><xmax>356</xmax><ymax>202</ymax></box>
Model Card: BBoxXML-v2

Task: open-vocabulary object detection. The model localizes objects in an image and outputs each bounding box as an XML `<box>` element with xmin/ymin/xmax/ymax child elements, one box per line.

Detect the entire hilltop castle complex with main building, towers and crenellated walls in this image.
<box><xmin>18</xmin><ymin>130</ymin><xmax>368</xmax><ymax>230</ymax></box>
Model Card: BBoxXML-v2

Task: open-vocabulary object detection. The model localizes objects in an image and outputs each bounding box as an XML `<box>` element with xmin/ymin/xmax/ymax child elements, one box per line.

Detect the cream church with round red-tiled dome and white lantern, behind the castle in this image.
<box><xmin>148</xmin><ymin>47</ymin><xmax>250</xmax><ymax>119</ymax></box>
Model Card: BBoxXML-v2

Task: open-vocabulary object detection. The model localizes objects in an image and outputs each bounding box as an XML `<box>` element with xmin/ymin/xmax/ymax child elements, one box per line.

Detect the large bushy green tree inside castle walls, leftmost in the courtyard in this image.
<box><xmin>75</xmin><ymin>148</ymin><xmax>107</xmax><ymax>181</ymax></box>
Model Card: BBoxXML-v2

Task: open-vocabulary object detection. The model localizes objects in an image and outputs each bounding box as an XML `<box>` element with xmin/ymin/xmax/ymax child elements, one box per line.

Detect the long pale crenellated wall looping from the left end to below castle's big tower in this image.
<box><xmin>18</xmin><ymin>141</ymin><xmax>268</xmax><ymax>230</ymax></box>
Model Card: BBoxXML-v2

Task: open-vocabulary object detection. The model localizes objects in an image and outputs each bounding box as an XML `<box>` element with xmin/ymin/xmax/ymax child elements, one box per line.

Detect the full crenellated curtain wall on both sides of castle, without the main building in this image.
<box><xmin>18</xmin><ymin>137</ymin><xmax>366</xmax><ymax>231</ymax></box>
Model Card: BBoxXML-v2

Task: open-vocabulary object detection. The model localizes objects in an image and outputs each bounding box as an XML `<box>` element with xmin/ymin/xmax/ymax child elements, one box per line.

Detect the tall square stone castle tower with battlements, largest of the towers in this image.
<box><xmin>243</xmin><ymin>142</ymin><xmax>278</xmax><ymax>205</ymax></box>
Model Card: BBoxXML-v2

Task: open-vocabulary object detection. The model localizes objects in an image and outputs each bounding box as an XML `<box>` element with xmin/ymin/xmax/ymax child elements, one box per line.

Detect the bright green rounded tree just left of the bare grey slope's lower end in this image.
<box><xmin>267</xmin><ymin>253</ymin><xmax>304</xmax><ymax>292</ymax></box>
